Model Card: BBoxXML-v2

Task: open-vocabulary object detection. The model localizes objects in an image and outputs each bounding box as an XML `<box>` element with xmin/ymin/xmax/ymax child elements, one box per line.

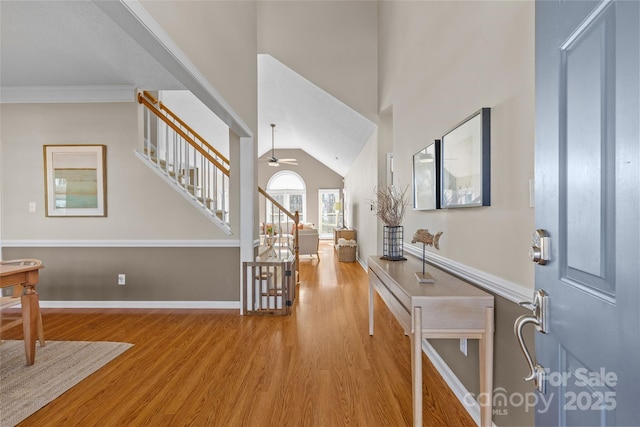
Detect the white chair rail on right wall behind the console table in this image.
<box><xmin>404</xmin><ymin>244</ymin><xmax>533</xmax><ymax>304</ymax></box>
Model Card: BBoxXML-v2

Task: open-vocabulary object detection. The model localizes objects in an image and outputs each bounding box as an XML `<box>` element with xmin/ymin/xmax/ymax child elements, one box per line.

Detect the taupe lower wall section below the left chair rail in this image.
<box><xmin>4</xmin><ymin>247</ymin><xmax>240</xmax><ymax>302</ymax></box>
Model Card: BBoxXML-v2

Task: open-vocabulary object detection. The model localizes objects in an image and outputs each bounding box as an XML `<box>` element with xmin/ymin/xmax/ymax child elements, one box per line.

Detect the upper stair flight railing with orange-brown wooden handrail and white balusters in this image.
<box><xmin>135</xmin><ymin>91</ymin><xmax>231</xmax><ymax>235</ymax></box>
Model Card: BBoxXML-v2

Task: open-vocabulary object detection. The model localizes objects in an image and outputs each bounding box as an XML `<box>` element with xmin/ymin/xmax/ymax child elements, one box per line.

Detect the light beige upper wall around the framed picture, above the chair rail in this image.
<box><xmin>0</xmin><ymin>102</ymin><xmax>237</xmax><ymax>240</ymax></box>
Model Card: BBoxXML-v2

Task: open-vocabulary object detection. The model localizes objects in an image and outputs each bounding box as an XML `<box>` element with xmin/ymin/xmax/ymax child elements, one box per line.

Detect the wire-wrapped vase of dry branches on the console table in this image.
<box><xmin>371</xmin><ymin>186</ymin><xmax>409</xmax><ymax>261</ymax></box>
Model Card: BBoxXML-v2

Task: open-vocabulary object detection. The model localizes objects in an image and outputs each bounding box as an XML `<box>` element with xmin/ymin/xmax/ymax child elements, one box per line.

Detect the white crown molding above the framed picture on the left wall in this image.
<box><xmin>0</xmin><ymin>85</ymin><xmax>137</xmax><ymax>104</ymax></box>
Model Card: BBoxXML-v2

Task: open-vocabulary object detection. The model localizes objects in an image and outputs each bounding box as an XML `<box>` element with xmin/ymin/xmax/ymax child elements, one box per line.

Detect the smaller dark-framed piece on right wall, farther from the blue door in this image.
<box><xmin>413</xmin><ymin>139</ymin><xmax>440</xmax><ymax>210</ymax></box>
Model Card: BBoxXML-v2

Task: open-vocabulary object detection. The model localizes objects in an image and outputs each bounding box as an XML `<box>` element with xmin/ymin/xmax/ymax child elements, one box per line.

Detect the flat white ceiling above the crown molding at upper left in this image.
<box><xmin>0</xmin><ymin>0</ymin><xmax>184</xmax><ymax>90</ymax></box>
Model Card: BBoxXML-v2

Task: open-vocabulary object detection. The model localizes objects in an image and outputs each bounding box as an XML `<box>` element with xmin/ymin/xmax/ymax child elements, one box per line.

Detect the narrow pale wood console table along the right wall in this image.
<box><xmin>368</xmin><ymin>255</ymin><xmax>494</xmax><ymax>426</ymax></box>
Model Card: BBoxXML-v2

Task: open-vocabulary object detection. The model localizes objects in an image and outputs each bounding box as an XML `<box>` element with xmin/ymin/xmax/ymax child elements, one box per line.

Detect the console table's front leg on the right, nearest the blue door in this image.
<box><xmin>478</xmin><ymin>307</ymin><xmax>493</xmax><ymax>427</ymax></box>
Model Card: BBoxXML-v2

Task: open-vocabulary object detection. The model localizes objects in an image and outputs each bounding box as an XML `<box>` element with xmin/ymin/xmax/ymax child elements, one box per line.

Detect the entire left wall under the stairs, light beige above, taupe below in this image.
<box><xmin>0</xmin><ymin>103</ymin><xmax>240</xmax><ymax>301</ymax></box>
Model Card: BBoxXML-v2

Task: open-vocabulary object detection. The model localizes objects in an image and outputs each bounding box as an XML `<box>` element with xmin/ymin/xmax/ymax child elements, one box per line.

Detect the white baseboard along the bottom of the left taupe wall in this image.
<box><xmin>40</xmin><ymin>301</ymin><xmax>240</xmax><ymax>310</ymax></box>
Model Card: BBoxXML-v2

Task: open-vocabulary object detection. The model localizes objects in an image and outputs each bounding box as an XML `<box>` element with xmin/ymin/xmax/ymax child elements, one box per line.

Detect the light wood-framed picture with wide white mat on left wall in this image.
<box><xmin>43</xmin><ymin>145</ymin><xmax>107</xmax><ymax>217</ymax></box>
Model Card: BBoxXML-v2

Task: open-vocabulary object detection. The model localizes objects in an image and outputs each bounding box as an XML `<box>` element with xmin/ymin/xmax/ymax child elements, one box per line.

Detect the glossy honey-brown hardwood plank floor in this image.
<box><xmin>3</xmin><ymin>242</ymin><xmax>475</xmax><ymax>427</ymax></box>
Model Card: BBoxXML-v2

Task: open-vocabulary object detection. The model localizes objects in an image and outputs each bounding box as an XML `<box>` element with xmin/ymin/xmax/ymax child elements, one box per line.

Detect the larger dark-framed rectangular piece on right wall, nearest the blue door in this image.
<box><xmin>439</xmin><ymin>108</ymin><xmax>491</xmax><ymax>208</ymax></box>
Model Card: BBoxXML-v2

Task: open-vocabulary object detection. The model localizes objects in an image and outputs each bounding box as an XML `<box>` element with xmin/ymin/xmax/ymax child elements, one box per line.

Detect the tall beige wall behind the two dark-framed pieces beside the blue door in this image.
<box><xmin>376</xmin><ymin>1</ymin><xmax>534</xmax><ymax>288</ymax></box>
